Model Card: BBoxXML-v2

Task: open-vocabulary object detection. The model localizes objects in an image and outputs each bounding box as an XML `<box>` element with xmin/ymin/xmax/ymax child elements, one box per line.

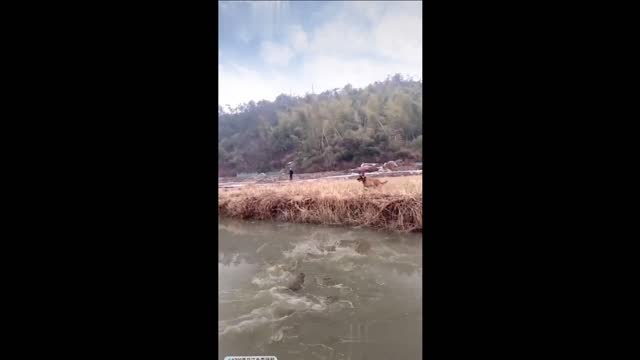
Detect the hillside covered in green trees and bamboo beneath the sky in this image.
<box><xmin>218</xmin><ymin>75</ymin><xmax>422</xmax><ymax>176</ymax></box>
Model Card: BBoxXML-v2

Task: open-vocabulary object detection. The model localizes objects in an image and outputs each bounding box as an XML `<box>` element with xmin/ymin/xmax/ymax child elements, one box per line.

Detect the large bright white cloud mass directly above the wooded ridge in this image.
<box><xmin>219</xmin><ymin>2</ymin><xmax>422</xmax><ymax>105</ymax></box>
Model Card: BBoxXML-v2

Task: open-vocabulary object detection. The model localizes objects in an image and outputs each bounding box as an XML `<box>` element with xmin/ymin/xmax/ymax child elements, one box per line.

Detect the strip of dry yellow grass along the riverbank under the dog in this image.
<box><xmin>218</xmin><ymin>176</ymin><xmax>422</xmax><ymax>231</ymax></box>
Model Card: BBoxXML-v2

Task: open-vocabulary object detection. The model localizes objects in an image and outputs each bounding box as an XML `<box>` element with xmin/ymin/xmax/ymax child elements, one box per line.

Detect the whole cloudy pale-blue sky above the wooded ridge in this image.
<box><xmin>218</xmin><ymin>1</ymin><xmax>422</xmax><ymax>107</ymax></box>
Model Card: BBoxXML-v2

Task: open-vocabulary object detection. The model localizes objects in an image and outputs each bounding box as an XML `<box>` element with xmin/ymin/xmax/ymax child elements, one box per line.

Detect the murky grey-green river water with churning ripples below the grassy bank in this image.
<box><xmin>218</xmin><ymin>219</ymin><xmax>422</xmax><ymax>360</ymax></box>
